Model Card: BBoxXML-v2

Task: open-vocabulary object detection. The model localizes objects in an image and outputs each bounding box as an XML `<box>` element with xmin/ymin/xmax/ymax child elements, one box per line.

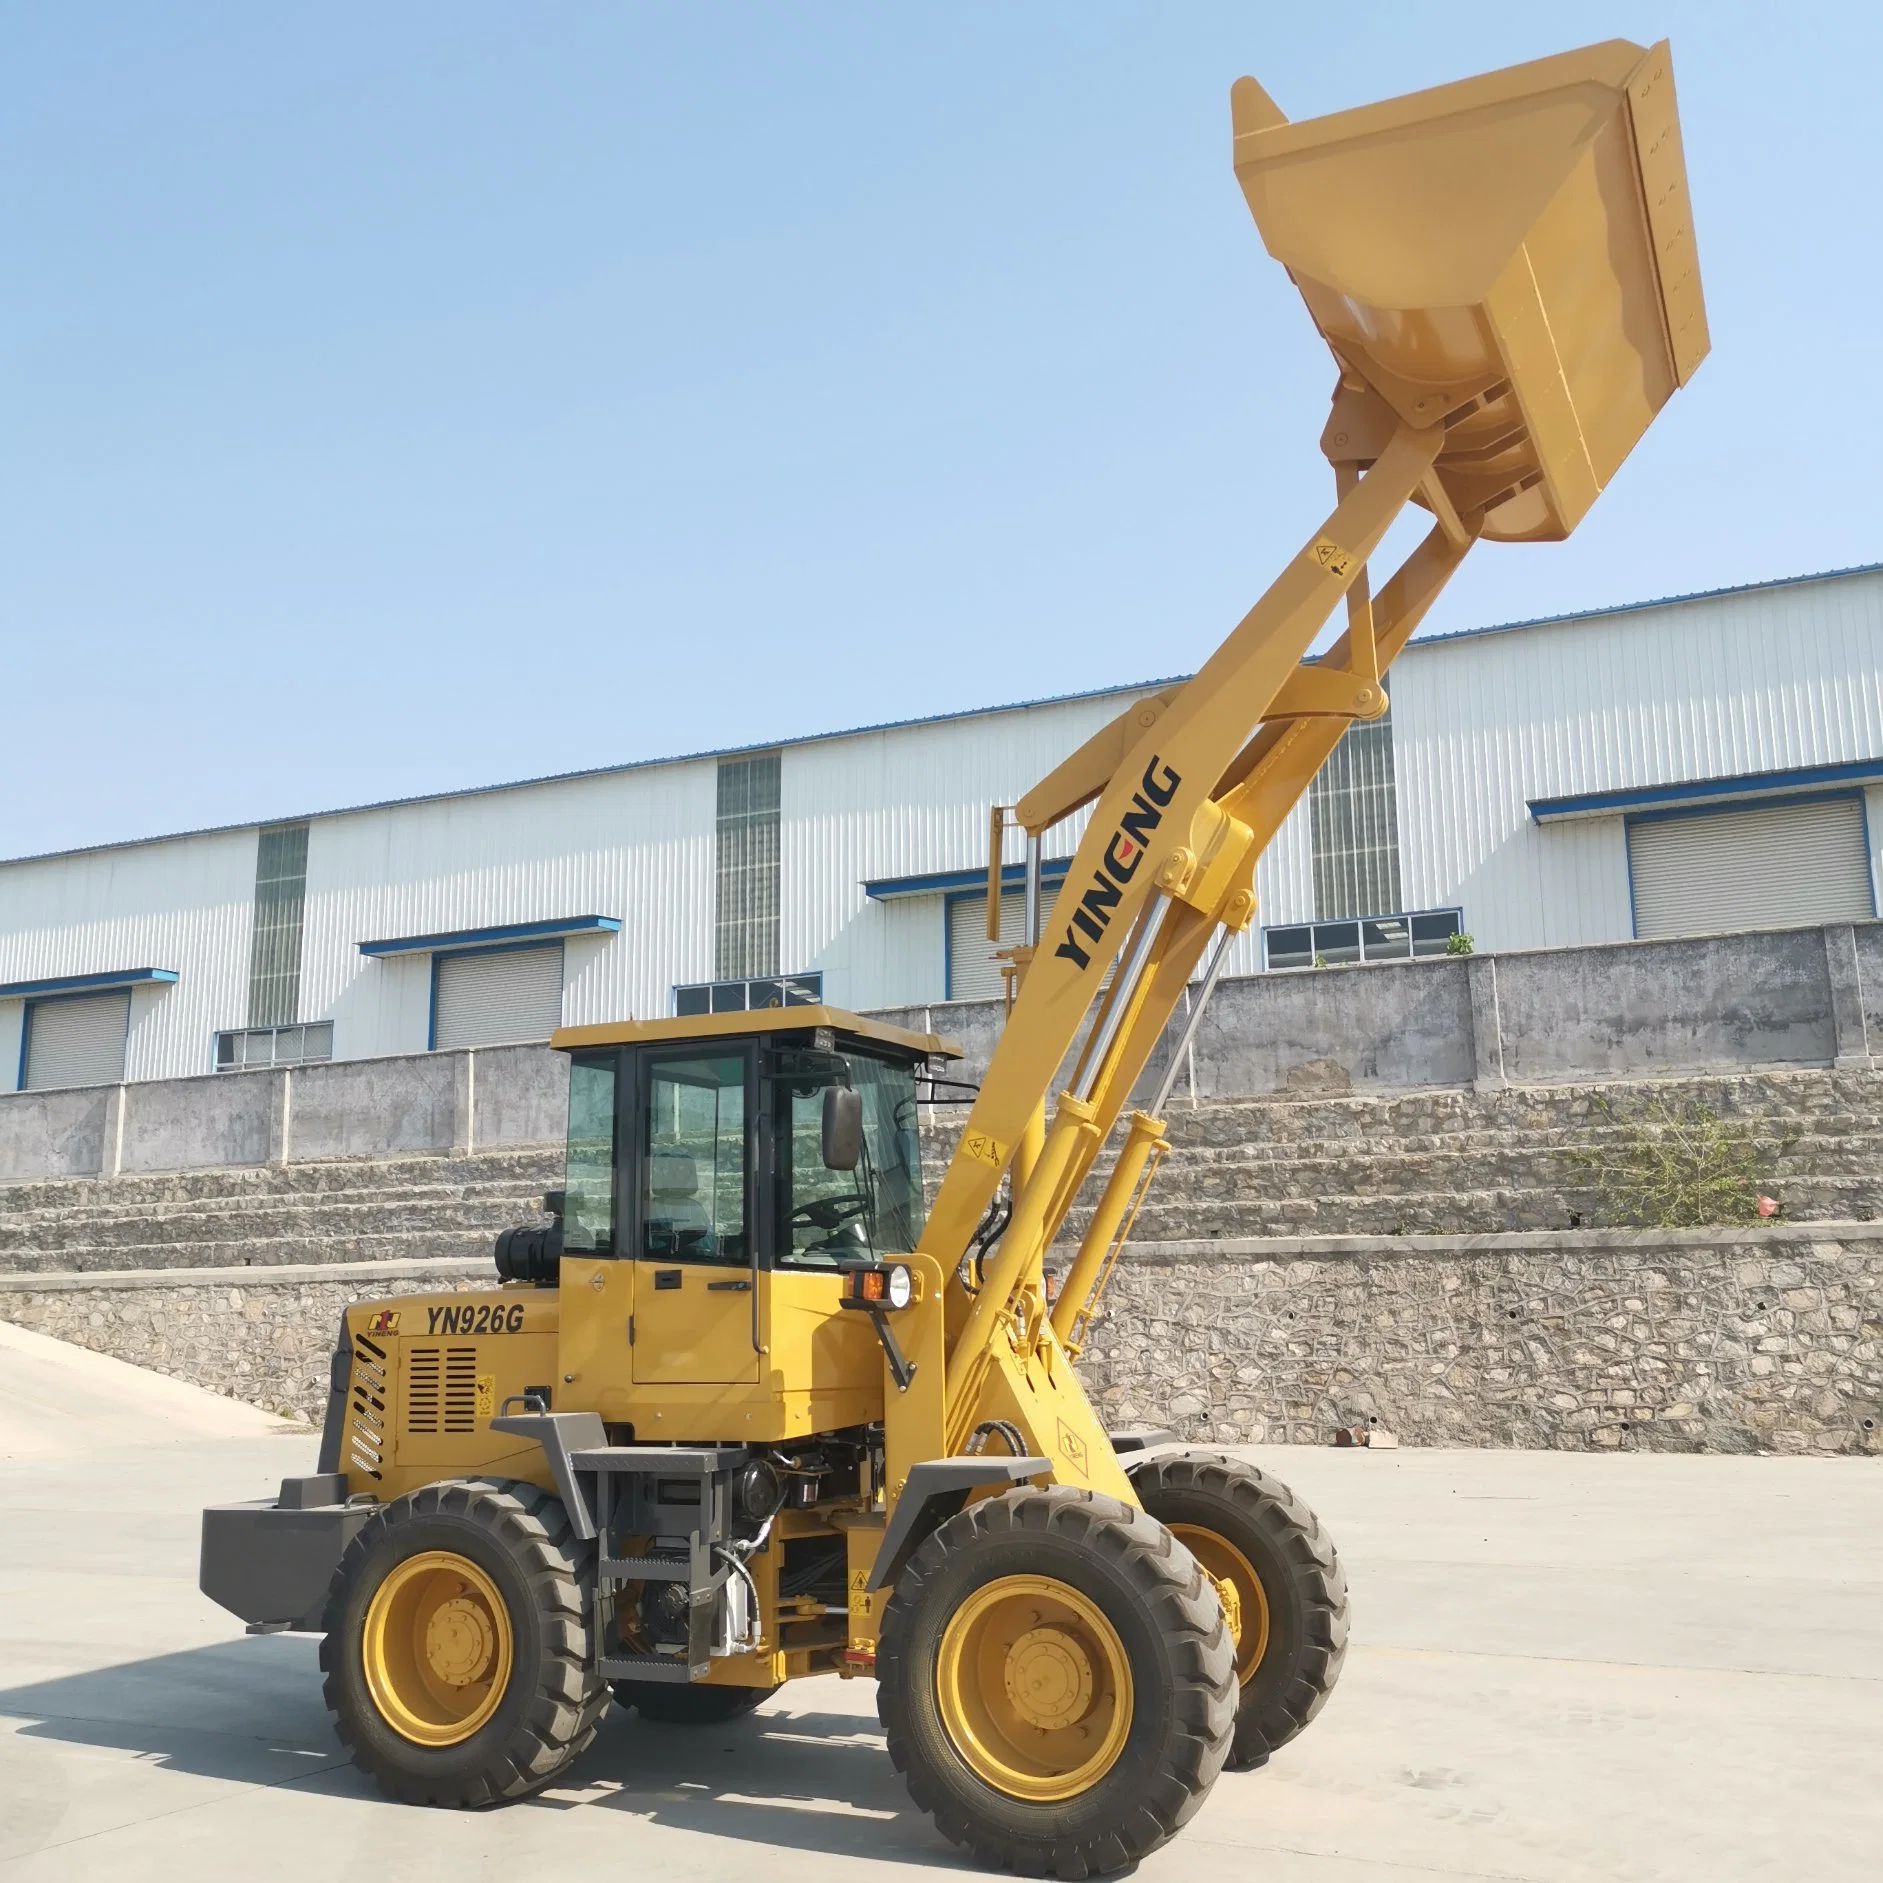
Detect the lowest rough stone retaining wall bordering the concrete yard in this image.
<box><xmin>0</xmin><ymin>1222</ymin><xmax>1883</xmax><ymax>1452</ymax></box>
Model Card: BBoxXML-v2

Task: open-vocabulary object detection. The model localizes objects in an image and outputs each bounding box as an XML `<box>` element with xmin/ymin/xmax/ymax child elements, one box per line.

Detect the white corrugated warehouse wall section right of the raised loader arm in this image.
<box><xmin>1393</xmin><ymin>572</ymin><xmax>1883</xmax><ymax>949</ymax></box>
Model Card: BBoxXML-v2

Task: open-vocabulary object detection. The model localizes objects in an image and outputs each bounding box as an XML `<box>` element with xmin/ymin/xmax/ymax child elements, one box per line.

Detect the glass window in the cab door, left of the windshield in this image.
<box><xmin>638</xmin><ymin>1054</ymin><xmax>751</xmax><ymax>1267</ymax></box>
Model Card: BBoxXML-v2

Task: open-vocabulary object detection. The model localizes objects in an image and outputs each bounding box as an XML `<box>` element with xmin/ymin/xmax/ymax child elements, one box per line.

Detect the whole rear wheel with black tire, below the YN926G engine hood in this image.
<box><xmin>320</xmin><ymin>1478</ymin><xmax>608</xmax><ymax>1806</ymax></box>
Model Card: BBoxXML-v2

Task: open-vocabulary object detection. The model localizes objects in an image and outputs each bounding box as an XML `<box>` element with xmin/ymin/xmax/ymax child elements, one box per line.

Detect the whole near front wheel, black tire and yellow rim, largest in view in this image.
<box><xmin>876</xmin><ymin>1486</ymin><xmax>1235</xmax><ymax>1877</ymax></box>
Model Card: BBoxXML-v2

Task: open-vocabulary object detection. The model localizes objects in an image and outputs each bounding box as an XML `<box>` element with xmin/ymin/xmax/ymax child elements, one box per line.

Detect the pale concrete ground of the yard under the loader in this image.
<box><xmin>0</xmin><ymin>1326</ymin><xmax>1883</xmax><ymax>1883</ymax></box>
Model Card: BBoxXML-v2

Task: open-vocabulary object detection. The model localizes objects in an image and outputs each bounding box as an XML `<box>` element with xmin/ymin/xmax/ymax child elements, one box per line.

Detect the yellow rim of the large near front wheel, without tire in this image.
<box><xmin>936</xmin><ymin>1576</ymin><xmax>1132</xmax><ymax>1804</ymax></box>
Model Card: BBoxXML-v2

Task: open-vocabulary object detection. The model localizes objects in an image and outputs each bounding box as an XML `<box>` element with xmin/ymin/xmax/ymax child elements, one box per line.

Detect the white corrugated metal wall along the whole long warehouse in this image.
<box><xmin>0</xmin><ymin>572</ymin><xmax>1883</xmax><ymax>1088</ymax></box>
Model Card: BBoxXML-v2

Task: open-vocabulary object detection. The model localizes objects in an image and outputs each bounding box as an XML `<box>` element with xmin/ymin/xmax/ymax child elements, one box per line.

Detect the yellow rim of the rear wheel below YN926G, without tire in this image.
<box><xmin>362</xmin><ymin>1550</ymin><xmax>514</xmax><ymax>1746</ymax></box>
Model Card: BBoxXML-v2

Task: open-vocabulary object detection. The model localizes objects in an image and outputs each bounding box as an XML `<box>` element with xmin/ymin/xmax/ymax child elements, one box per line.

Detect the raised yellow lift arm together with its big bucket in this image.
<box><xmin>907</xmin><ymin>40</ymin><xmax>1708</xmax><ymax>1488</ymax></box>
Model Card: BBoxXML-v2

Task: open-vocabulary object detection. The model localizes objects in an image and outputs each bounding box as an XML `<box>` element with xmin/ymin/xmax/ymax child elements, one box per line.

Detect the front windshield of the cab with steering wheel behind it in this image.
<box><xmin>770</xmin><ymin>1047</ymin><xmax>925</xmax><ymax>1269</ymax></box>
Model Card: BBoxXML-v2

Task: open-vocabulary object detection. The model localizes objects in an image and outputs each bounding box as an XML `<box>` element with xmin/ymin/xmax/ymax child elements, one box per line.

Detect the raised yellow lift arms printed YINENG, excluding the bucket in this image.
<box><xmin>923</xmin><ymin>427</ymin><xmax>1473</xmax><ymax>1439</ymax></box>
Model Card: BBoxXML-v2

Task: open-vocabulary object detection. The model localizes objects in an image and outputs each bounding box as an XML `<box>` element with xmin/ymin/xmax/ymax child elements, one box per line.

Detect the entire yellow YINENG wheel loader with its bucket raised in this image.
<box><xmin>201</xmin><ymin>41</ymin><xmax>1706</xmax><ymax>1877</ymax></box>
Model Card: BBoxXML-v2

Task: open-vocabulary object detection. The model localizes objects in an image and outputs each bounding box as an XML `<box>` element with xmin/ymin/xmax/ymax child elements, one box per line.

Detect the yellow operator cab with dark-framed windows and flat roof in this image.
<box><xmin>538</xmin><ymin>1006</ymin><xmax>960</xmax><ymax>1416</ymax></box>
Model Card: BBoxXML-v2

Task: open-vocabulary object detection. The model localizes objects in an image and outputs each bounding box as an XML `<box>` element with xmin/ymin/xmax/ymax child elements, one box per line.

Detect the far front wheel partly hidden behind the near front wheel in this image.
<box><xmin>1130</xmin><ymin>1452</ymin><xmax>1348</xmax><ymax>1772</ymax></box>
